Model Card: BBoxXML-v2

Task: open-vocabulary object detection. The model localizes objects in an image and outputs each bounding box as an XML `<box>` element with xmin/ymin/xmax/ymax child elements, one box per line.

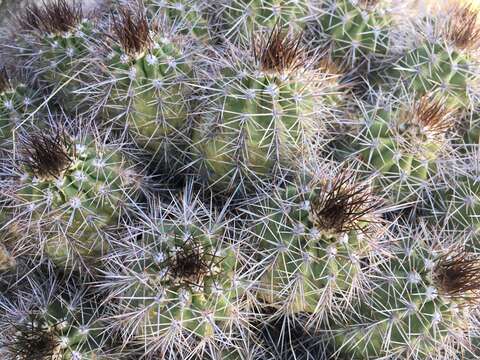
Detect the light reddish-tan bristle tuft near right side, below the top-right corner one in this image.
<box><xmin>414</xmin><ymin>96</ymin><xmax>452</xmax><ymax>134</ymax></box>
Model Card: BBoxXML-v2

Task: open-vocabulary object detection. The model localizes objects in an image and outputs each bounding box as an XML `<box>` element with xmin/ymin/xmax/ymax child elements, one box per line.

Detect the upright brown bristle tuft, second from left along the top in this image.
<box><xmin>112</xmin><ymin>6</ymin><xmax>152</xmax><ymax>55</ymax></box>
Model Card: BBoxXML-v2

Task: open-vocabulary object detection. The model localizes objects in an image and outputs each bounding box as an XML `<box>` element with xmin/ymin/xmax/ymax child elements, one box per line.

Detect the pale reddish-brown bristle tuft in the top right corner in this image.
<box><xmin>445</xmin><ymin>5</ymin><xmax>480</xmax><ymax>50</ymax></box>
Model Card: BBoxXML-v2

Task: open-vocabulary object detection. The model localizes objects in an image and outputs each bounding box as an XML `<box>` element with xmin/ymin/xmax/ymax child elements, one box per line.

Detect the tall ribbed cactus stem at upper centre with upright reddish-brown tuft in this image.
<box><xmin>192</xmin><ymin>26</ymin><xmax>332</xmax><ymax>193</ymax></box>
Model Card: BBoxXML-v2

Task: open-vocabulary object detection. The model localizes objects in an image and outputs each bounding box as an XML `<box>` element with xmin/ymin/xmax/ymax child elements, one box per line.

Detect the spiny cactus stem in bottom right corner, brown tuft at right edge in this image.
<box><xmin>329</xmin><ymin>234</ymin><xmax>480</xmax><ymax>360</ymax></box>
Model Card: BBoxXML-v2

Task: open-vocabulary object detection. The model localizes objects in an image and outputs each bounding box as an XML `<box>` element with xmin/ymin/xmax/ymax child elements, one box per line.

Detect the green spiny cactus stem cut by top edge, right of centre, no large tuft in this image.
<box><xmin>309</xmin><ymin>0</ymin><xmax>390</xmax><ymax>68</ymax></box>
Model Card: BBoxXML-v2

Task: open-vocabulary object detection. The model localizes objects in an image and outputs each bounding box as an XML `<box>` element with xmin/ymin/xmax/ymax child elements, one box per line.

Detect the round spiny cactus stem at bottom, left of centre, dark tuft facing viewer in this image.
<box><xmin>100</xmin><ymin>194</ymin><xmax>246</xmax><ymax>359</ymax></box>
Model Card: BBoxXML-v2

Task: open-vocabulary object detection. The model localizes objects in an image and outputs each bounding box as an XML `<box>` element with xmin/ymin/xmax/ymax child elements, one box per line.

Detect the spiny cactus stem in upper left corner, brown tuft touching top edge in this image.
<box><xmin>15</xmin><ymin>0</ymin><xmax>95</xmax><ymax>110</ymax></box>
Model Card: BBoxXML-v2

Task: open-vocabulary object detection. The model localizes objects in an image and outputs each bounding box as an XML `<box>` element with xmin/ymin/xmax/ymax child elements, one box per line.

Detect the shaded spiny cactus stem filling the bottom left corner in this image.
<box><xmin>0</xmin><ymin>264</ymin><xmax>106</xmax><ymax>360</ymax></box>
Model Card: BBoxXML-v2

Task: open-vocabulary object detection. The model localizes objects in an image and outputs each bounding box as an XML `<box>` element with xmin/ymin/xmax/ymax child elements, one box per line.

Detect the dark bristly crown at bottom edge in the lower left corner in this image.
<box><xmin>8</xmin><ymin>314</ymin><xmax>60</xmax><ymax>360</ymax></box>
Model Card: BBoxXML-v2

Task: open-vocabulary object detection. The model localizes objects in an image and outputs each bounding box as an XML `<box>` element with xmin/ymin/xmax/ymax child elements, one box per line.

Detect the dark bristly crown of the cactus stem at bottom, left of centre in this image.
<box><xmin>161</xmin><ymin>235</ymin><xmax>222</xmax><ymax>287</ymax></box>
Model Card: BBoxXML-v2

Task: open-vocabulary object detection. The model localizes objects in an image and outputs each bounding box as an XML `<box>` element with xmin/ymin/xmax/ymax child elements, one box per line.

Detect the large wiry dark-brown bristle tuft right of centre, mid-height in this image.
<box><xmin>310</xmin><ymin>170</ymin><xmax>383</xmax><ymax>233</ymax></box>
